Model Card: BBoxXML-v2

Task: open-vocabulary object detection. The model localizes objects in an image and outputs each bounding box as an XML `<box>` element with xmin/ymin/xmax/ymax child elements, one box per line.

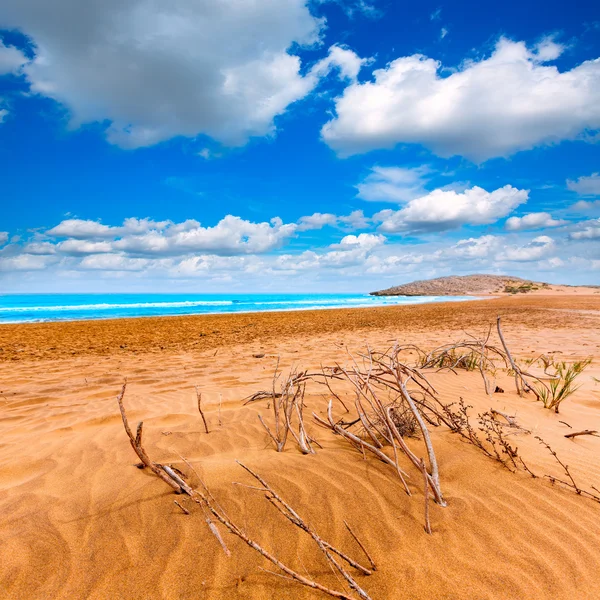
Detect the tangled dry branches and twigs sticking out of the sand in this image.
<box><xmin>118</xmin><ymin>318</ymin><xmax>600</xmax><ymax>600</ymax></box>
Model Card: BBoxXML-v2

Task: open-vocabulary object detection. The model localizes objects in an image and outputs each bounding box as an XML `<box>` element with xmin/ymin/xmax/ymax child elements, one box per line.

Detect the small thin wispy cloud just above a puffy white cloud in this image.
<box><xmin>356</xmin><ymin>166</ymin><xmax>431</xmax><ymax>202</ymax></box>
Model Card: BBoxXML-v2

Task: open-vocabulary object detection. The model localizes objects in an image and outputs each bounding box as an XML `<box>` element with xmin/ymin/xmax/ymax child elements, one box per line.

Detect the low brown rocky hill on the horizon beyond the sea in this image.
<box><xmin>371</xmin><ymin>274</ymin><xmax>552</xmax><ymax>296</ymax></box>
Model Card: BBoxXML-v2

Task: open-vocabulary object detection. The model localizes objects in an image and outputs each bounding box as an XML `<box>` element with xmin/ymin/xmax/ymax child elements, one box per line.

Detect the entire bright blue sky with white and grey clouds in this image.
<box><xmin>0</xmin><ymin>0</ymin><xmax>600</xmax><ymax>293</ymax></box>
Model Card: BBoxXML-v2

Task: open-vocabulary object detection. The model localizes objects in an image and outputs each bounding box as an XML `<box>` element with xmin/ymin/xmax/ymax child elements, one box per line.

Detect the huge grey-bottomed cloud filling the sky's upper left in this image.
<box><xmin>0</xmin><ymin>0</ymin><xmax>362</xmax><ymax>148</ymax></box>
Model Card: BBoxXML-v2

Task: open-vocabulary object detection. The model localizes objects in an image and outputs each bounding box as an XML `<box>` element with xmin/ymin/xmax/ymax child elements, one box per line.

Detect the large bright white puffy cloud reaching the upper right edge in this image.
<box><xmin>322</xmin><ymin>38</ymin><xmax>600</xmax><ymax>162</ymax></box>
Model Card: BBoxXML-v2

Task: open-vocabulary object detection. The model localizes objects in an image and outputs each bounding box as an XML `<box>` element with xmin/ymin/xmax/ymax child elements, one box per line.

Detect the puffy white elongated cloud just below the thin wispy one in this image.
<box><xmin>373</xmin><ymin>185</ymin><xmax>529</xmax><ymax>233</ymax></box>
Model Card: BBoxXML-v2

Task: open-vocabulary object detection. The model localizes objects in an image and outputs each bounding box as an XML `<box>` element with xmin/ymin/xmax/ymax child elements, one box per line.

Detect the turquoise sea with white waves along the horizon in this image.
<box><xmin>0</xmin><ymin>294</ymin><xmax>475</xmax><ymax>323</ymax></box>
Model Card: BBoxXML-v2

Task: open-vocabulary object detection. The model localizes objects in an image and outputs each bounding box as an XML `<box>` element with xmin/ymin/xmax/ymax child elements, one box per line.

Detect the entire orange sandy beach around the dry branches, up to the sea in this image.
<box><xmin>0</xmin><ymin>293</ymin><xmax>600</xmax><ymax>600</ymax></box>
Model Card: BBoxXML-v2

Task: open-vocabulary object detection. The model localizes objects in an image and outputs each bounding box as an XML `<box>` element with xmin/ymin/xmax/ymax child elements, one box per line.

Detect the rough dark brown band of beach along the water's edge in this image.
<box><xmin>0</xmin><ymin>295</ymin><xmax>600</xmax><ymax>363</ymax></box>
